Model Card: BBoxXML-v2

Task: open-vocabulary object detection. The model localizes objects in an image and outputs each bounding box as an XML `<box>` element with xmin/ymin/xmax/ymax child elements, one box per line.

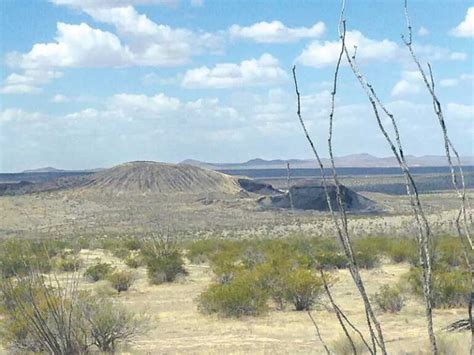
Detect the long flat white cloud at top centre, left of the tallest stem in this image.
<box><xmin>229</xmin><ymin>21</ymin><xmax>326</xmax><ymax>43</ymax></box>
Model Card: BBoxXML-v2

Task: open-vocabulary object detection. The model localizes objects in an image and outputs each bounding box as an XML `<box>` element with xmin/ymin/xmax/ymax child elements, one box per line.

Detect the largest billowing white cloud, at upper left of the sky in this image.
<box><xmin>7</xmin><ymin>5</ymin><xmax>223</xmax><ymax>68</ymax></box>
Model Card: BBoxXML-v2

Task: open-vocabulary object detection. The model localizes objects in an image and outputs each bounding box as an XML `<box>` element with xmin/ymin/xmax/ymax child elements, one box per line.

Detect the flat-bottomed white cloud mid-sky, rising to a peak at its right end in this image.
<box><xmin>181</xmin><ymin>53</ymin><xmax>287</xmax><ymax>89</ymax></box>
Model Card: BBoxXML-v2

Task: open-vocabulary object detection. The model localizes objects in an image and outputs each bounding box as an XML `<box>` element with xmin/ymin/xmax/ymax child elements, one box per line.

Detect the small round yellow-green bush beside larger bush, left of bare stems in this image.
<box><xmin>284</xmin><ymin>268</ymin><xmax>323</xmax><ymax>311</ymax></box>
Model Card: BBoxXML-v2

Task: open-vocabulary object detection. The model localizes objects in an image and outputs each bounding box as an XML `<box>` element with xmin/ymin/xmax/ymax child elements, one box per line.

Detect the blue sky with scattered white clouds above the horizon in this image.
<box><xmin>0</xmin><ymin>0</ymin><xmax>474</xmax><ymax>172</ymax></box>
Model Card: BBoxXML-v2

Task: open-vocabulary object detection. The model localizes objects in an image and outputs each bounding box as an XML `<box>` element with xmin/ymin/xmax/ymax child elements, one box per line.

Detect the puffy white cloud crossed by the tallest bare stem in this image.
<box><xmin>297</xmin><ymin>31</ymin><xmax>399</xmax><ymax>68</ymax></box>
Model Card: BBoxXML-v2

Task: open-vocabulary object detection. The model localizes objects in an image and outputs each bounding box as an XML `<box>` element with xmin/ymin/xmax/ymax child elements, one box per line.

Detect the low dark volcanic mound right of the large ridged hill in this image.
<box><xmin>260</xmin><ymin>185</ymin><xmax>374</xmax><ymax>211</ymax></box>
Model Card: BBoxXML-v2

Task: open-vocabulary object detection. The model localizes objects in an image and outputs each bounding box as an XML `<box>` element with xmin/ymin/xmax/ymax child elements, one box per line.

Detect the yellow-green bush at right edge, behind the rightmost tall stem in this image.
<box><xmin>404</xmin><ymin>268</ymin><xmax>471</xmax><ymax>308</ymax></box>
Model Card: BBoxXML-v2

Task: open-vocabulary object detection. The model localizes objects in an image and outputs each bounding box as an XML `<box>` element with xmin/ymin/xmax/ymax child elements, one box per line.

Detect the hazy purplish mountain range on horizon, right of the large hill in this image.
<box><xmin>181</xmin><ymin>153</ymin><xmax>474</xmax><ymax>170</ymax></box>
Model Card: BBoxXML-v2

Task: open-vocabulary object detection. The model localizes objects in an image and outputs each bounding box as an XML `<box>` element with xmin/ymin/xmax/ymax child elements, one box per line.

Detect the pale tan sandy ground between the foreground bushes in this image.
<box><xmin>72</xmin><ymin>251</ymin><xmax>469</xmax><ymax>355</ymax></box>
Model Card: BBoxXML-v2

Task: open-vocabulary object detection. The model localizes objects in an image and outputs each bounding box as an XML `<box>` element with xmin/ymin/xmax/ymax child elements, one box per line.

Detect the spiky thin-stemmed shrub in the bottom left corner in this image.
<box><xmin>0</xmin><ymin>273</ymin><xmax>86</xmax><ymax>354</ymax></box>
